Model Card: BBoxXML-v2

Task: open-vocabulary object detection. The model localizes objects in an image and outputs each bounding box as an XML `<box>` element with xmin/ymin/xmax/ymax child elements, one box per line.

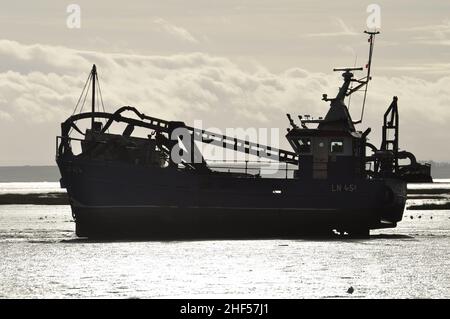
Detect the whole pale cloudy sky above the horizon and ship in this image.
<box><xmin>0</xmin><ymin>0</ymin><xmax>450</xmax><ymax>165</ymax></box>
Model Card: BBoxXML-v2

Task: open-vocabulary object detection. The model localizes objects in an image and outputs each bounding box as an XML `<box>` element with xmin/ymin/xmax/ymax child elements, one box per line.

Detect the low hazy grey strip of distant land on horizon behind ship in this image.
<box><xmin>0</xmin><ymin>161</ymin><xmax>450</xmax><ymax>183</ymax></box>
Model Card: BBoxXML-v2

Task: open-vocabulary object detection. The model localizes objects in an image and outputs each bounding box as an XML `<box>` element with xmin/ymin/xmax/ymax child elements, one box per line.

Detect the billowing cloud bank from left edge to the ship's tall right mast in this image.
<box><xmin>0</xmin><ymin>40</ymin><xmax>328</xmax><ymax>125</ymax></box>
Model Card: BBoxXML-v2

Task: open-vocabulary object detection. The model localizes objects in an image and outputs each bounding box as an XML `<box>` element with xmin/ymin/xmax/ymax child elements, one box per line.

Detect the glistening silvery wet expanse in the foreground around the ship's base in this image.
<box><xmin>0</xmin><ymin>183</ymin><xmax>450</xmax><ymax>298</ymax></box>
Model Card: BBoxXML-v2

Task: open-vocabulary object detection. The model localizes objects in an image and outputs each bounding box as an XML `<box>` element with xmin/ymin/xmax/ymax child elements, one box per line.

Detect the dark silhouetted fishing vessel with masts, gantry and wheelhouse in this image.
<box><xmin>56</xmin><ymin>31</ymin><xmax>431</xmax><ymax>238</ymax></box>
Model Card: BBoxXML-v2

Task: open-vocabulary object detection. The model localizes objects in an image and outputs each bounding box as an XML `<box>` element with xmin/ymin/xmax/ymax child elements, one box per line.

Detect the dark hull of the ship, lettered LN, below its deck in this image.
<box><xmin>58</xmin><ymin>160</ymin><xmax>406</xmax><ymax>238</ymax></box>
